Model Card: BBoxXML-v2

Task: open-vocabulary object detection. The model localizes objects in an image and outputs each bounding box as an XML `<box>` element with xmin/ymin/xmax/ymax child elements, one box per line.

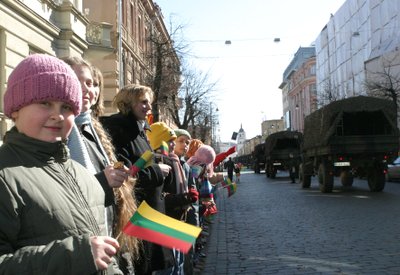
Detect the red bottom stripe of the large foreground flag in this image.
<box><xmin>124</xmin><ymin>223</ymin><xmax>192</xmax><ymax>253</ymax></box>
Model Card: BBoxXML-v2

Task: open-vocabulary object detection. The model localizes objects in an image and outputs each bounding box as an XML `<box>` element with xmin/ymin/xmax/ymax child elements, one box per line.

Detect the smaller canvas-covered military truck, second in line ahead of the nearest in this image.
<box><xmin>265</xmin><ymin>131</ymin><xmax>303</xmax><ymax>182</ymax></box>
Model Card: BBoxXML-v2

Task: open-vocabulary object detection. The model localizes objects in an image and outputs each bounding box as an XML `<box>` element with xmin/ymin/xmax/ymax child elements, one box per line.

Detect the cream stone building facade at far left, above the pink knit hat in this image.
<box><xmin>0</xmin><ymin>0</ymin><xmax>88</xmax><ymax>144</ymax></box>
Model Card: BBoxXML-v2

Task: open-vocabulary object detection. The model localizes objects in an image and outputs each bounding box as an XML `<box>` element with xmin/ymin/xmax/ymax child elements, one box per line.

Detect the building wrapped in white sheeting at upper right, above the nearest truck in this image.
<box><xmin>315</xmin><ymin>0</ymin><xmax>400</xmax><ymax>106</ymax></box>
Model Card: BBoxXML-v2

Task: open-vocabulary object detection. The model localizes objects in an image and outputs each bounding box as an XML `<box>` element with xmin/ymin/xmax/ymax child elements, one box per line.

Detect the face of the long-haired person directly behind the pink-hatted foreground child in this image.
<box><xmin>72</xmin><ymin>65</ymin><xmax>96</xmax><ymax>113</ymax></box>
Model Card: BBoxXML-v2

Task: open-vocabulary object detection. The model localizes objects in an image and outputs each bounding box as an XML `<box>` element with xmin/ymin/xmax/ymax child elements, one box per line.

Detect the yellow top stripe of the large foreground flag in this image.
<box><xmin>136</xmin><ymin>201</ymin><xmax>201</xmax><ymax>238</ymax></box>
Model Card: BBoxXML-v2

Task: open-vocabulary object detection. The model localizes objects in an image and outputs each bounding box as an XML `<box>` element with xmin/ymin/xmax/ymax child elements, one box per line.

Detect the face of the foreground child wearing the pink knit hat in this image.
<box><xmin>11</xmin><ymin>101</ymin><xmax>75</xmax><ymax>142</ymax></box>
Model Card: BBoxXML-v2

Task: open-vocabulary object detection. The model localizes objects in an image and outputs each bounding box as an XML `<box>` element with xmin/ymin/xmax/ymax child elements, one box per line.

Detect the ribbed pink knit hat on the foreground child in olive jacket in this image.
<box><xmin>4</xmin><ymin>54</ymin><xmax>82</xmax><ymax>118</ymax></box>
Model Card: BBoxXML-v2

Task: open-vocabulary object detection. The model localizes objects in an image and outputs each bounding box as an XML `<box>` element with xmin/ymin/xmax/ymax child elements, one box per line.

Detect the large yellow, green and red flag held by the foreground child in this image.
<box><xmin>123</xmin><ymin>201</ymin><xmax>201</xmax><ymax>253</ymax></box>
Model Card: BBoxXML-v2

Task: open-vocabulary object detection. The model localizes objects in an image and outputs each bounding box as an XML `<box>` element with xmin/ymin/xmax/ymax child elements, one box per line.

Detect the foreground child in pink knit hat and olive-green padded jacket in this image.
<box><xmin>0</xmin><ymin>54</ymin><xmax>122</xmax><ymax>274</ymax></box>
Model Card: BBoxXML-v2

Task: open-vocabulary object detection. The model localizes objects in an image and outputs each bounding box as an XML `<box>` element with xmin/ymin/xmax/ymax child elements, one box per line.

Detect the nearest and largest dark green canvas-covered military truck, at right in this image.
<box><xmin>300</xmin><ymin>96</ymin><xmax>399</xmax><ymax>193</ymax></box>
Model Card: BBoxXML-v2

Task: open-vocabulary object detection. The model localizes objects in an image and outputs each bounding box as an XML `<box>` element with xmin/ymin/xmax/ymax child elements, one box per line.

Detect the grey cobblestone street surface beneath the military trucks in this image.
<box><xmin>196</xmin><ymin>173</ymin><xmax>400</xmax><ymax>275</ymax></box>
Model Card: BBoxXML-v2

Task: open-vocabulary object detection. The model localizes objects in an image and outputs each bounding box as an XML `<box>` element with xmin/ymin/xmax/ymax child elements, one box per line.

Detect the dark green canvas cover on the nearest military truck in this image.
<box><xmin>303</xmin><ymin>96</ymin><xmax>398</xmax><ymax>150</ymax></box>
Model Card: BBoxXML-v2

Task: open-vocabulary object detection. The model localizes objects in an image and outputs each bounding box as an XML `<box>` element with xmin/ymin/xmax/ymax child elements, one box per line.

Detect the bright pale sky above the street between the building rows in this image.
<box><xmin>155</xmin><ymin>0</ymin><xmax>345</xmax><ymax>141</ymax></box>
